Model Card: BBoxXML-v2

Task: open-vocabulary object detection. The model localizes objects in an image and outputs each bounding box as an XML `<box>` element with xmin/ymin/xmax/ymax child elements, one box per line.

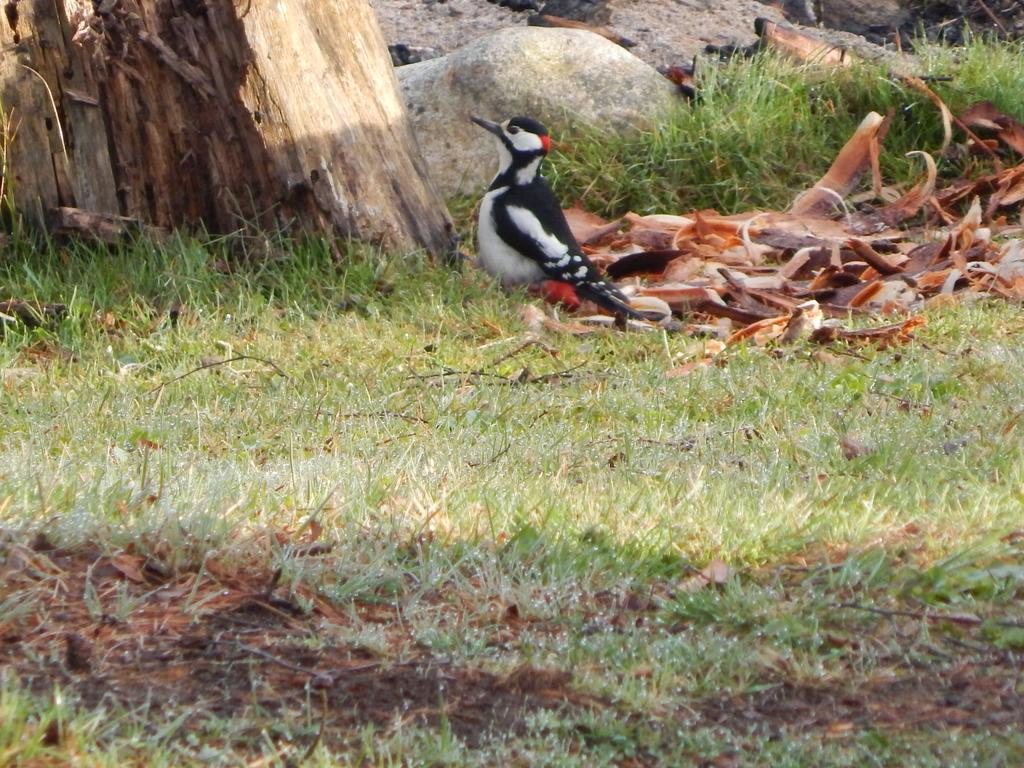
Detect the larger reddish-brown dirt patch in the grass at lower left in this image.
<box><xmin>0</xmin><ymin>547</ymin><xmax>597</xmax><ymax>745</ymax></box>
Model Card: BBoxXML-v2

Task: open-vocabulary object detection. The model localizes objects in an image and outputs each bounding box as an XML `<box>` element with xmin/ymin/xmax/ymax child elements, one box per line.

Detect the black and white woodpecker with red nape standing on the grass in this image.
<box><xmin>472</xmin><ymin>118</ymin><xmax>646</xmax><ymax>317</ymax></box>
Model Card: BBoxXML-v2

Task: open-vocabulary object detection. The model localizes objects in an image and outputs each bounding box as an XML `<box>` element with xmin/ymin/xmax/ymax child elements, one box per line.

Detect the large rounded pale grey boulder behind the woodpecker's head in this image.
<box><xmin>395</xmin><ymin>27</ymin><xmax>679</xmax><ymax>197</ymax></box>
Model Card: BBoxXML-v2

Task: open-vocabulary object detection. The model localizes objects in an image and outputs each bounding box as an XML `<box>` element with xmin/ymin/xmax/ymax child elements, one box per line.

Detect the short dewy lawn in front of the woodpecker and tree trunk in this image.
<box><xmin>0</xmin><ymin>242</ymin><xmax>1024</xmax><ymax>765</ymax></box>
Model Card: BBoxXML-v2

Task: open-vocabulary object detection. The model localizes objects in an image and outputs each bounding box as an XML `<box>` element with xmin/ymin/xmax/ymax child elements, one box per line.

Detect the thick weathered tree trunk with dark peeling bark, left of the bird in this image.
<box><xmin>0</xmin><ymin>0</ymin><xmax>454</xmax><ymax>259</ymax></box>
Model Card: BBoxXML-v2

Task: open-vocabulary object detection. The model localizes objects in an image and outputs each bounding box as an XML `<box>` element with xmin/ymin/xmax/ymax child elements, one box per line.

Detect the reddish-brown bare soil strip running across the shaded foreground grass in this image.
<box><xmin>0</xmin><ymin>540</ymin><xmax>1024</xmax><ymax>746</ymax></box>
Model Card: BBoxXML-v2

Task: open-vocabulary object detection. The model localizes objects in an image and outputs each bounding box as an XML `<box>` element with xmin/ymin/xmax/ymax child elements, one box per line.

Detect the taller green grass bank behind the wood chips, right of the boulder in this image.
<box><xmin>547</xmin><ymin>40</ymin><xmax>1024</xmax><ymax>216</ymax></box>
